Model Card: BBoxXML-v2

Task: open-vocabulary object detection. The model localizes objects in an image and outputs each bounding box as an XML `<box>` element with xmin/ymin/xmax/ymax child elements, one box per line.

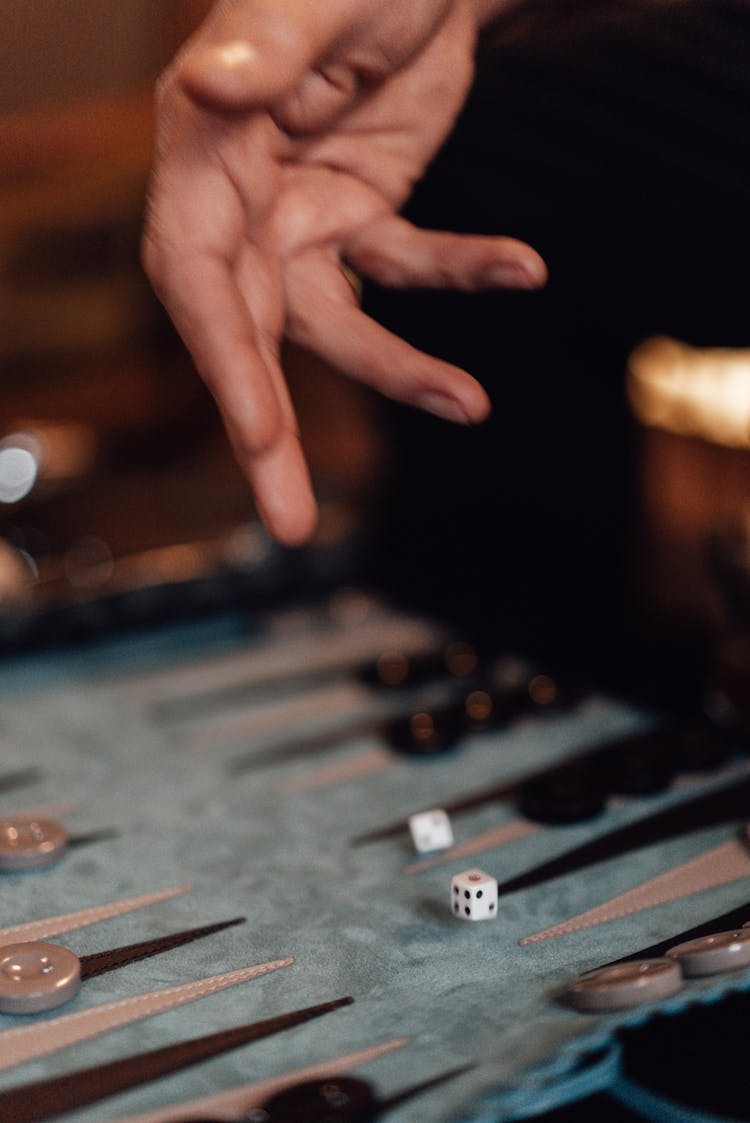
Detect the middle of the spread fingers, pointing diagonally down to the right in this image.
<box><xmin>287</xmin><ymin>258</ymin><xmax>490</xmax><ymax>424</ymax></box>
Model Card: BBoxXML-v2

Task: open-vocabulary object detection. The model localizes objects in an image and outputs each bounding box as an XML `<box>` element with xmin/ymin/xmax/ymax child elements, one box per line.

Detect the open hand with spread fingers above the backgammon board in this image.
<box><xmin>144</xmin><ymin>0</ymin><xmax>546</xmax><ymax>545</ymax></box>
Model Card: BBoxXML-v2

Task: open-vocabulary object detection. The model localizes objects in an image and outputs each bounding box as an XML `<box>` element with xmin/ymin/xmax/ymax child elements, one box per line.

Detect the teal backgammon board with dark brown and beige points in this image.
<box><xmin>0</xmin><ymin>590</ymin><xmax>750</xmax><ymax>1123</ymax></box>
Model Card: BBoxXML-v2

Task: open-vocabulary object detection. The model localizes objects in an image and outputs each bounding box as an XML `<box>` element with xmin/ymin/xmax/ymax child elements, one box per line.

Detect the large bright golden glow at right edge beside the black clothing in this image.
<box><xmin>628</xmin><ymin>338</ymin><xmax>750</xmax><ymax>448</ymax></box>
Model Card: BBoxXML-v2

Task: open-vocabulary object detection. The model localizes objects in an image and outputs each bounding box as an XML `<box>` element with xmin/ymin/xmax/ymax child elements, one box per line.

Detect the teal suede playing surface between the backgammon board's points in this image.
<box><xmin>0</xmin><ymin>601</ymin><xmax>750</xmax><ymax>1123</ymax></box>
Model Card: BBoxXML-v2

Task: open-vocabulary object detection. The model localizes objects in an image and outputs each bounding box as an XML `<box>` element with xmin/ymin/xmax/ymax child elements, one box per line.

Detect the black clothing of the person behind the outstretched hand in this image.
<box><xmin>366</xmin><ymin>0</ymin><xmax>750</xmax><ymax>700</ymax></box>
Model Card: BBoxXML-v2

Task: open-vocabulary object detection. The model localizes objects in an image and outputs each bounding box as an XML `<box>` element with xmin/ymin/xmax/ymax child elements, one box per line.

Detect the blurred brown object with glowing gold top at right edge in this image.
<box><xmin>628</xmin><ymin>338</ymin><xmax>750</xmax><ymax>709</ymax></box>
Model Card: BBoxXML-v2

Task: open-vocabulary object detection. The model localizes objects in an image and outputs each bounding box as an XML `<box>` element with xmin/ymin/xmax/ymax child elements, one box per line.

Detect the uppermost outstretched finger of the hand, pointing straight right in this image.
<box><xmin>345</xmin><ymin>217</ymin><xmax>547</xmax><ymax>292</ymax></box>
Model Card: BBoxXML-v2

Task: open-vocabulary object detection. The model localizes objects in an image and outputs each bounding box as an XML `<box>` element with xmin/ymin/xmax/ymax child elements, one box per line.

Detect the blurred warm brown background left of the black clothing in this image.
<box><xmin>0</xmin><ymin>0</ymin><xmax>386</xmax><ymax>647</ymax></box>
